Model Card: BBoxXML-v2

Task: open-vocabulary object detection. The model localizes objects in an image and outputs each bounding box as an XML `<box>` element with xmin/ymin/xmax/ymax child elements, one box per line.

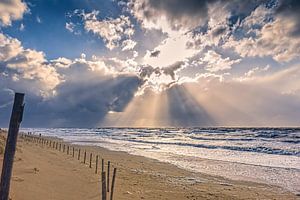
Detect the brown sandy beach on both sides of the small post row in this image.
<box><xmin>0</xmin><ymin>130</ymin><xmax>299</xmax><ymax>200</ymax></box>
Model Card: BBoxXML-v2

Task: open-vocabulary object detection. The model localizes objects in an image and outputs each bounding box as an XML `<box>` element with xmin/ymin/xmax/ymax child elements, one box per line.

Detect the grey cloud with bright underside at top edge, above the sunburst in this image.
<box><xmin>128</xmin><ymin>0</ymin><xmax>216</xmax><ymax>32</ymax></box>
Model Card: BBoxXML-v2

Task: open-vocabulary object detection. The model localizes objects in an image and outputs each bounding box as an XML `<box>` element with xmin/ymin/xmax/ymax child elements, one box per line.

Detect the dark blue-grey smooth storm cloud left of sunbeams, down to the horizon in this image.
<box><xmin>0</xmin><ymin>76</ymin><xmax>141</xmax><ymax>127</ymax></box>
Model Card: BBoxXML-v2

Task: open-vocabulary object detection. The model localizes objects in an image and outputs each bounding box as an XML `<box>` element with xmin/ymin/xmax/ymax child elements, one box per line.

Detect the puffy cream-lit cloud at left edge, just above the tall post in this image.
<box><xmin>0</xmin><ymin>34</ymin><xmax>61</xmax><ymax>97</ymax></box>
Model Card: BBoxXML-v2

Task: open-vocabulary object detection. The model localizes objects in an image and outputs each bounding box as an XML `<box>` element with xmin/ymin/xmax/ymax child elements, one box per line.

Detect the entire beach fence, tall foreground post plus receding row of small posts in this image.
<box><xmin>0</xmin><ymin>93</ymin><xmax>117</xmax><ymax>200</ymax></box>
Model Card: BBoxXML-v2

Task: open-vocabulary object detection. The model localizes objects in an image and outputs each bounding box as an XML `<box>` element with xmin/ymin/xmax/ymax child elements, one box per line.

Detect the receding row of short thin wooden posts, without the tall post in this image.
<box><xmin>21</xmin><ymin>132</ymin><xmax>117</xmax><ymax>200</ymax></box>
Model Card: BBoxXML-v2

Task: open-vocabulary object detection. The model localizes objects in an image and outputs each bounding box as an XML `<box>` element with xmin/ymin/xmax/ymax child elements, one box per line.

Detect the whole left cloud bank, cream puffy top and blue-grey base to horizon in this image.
<box><xmin>0</xmin><ymin>34</ymin><xmax>143</xmax><ymax>127</ymax></box>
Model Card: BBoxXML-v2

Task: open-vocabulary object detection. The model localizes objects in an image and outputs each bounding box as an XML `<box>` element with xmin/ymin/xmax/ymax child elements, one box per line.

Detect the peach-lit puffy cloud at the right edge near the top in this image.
<box><xmin>224</xmin><ymin>6</ymin><xmax>300</xmax><ymax>62</ymax></box>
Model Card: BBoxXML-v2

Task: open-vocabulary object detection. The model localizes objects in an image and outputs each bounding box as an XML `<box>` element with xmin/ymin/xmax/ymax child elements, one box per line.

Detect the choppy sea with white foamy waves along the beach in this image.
<box><xmin>22</xmin><ymin>127</ymin><xmax>300</xmax><ymax>194</ymax></box>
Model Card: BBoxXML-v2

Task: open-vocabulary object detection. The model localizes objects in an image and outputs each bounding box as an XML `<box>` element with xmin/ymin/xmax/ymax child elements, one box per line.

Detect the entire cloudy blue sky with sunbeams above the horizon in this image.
<box><xmin>0</xmin><ymin>0</ymin><xmax>300</xmax><ymax>127</ymax></box>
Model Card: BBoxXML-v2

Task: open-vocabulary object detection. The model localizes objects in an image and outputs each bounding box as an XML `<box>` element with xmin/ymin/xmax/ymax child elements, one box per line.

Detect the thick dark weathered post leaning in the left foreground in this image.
<box><xmin>0</xmin><ymin>93</ymin><xmax>25</xmax><ymax>200</ymax></box>
